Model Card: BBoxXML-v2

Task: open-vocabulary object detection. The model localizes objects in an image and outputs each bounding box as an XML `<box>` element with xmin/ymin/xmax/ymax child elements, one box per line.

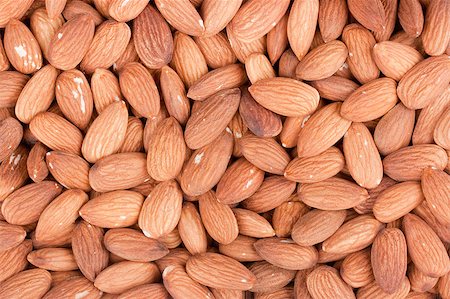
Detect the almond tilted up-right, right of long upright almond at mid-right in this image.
<box><xmin>373</xmin><ymin>103</ymin><xmax>415</xmax><ymax>156</ymax></box>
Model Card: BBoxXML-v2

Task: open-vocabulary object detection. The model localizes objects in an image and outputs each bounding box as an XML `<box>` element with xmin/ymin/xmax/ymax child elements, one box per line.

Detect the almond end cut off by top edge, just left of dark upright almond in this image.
<box><xmin>108</xmin><ymin>0</ymin><xmax>148</xmax><ymax>22</ymax></box>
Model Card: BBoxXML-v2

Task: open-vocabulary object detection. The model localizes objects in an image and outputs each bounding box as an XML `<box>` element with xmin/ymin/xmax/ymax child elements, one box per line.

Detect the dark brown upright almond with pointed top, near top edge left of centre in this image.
<box><xmin>133</xmin><ymin>5</ymin><xmax>173</xmax><ymax>69</ymax></box>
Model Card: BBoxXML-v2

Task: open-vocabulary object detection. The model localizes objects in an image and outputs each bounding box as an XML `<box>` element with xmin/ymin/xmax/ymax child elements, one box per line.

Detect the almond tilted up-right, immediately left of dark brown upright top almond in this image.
<box><xmin>80</xmin><ymin>21</ymin><xmax>131</xmax><ymax>73</ymax></box>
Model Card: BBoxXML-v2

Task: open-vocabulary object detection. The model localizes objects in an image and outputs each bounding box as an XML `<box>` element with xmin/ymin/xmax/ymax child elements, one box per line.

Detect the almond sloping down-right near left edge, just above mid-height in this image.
<box><xmin>30</xmin><ymin>112</ymin><xmax>83</xmax><ymax>155</ymax></box>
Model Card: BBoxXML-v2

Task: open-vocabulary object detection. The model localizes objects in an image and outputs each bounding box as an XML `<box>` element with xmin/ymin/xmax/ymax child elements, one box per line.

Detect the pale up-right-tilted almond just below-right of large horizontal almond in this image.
<box><xmin>297</xmin><ymin>103</ymin><xmax>351</xmax><ymax>158</ymax></box>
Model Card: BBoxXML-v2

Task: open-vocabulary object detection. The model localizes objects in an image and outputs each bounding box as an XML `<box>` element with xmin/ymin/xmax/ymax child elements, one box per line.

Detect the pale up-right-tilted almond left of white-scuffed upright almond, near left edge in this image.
<box><xmin>15</xmin><ymin>65</ymin><xmax>58</xmax><ymax>123</ymax></box>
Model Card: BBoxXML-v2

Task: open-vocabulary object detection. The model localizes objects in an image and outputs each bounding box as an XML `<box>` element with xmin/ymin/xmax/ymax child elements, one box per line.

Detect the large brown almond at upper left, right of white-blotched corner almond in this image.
<box><xmin>47</xmin><ymin>14</ymin><xmax>95</xmax><ymax>70</ymax></box>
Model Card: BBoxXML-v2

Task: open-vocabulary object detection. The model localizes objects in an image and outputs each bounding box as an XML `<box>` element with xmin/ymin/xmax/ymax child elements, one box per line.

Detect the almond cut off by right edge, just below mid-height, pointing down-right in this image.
<box><xmin>421</xmin><ymin>168</ymin><xmax>450</xmax><ymax>225</ymax></box>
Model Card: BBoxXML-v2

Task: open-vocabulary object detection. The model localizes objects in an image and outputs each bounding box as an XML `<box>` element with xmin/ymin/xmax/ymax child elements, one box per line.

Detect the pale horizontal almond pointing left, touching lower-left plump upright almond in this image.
<box><xmin>79</xmin><ymin>190</ymin><xmax>144</xmax><ymax>228</ymax></box>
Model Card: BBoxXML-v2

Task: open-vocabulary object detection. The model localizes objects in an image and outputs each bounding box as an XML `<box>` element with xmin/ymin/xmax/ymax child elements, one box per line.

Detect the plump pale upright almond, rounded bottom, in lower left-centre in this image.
<box><xmin>139</xmin><ymin>180</ymin><xmax>183</xmax><ymax>239</ymax></box>
